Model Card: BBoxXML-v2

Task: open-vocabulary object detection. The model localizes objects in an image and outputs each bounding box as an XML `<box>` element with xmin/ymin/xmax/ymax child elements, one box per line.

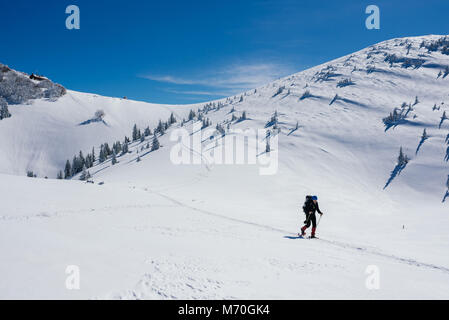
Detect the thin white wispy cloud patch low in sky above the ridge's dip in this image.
<box><xmin>141</xmin><ymin>63</ymin><xmax>294</xmax><ymax>96</ymax></box>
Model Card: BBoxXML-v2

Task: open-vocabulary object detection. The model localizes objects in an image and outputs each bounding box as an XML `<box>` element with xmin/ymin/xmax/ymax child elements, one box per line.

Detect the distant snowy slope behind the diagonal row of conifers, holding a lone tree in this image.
<box><xmin>0</xmin><ymin>90</ymin><xmax>195</xmax><ymax>178</ymax></box>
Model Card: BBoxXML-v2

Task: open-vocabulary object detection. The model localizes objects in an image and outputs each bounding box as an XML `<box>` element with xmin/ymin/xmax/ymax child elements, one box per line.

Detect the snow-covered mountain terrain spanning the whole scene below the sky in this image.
<box><xmin>0</xmin><ymin>35</ymin><xmax>449</xmax><ymax>299</ymax></box>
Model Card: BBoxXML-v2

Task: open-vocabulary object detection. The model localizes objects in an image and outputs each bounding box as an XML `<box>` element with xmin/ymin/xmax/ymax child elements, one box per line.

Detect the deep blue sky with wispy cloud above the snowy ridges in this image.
<box><xmin>0</xmin><ymin>0</ymin><xmax>449</xmax><ymax>104</ymax></box>
